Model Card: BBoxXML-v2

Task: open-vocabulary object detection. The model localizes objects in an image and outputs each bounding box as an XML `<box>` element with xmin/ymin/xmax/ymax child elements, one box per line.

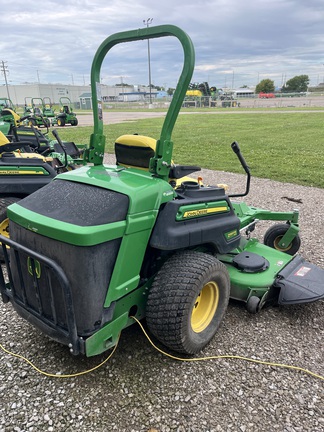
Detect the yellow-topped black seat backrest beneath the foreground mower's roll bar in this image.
<box><xmin>115</xmin><ymin>135</ymin><xmax>156</xmax><ymax>170</ymax></box>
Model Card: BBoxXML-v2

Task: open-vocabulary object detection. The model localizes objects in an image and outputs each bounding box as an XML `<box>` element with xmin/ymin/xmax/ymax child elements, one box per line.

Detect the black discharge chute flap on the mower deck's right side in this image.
<box><xmin>276</xmin><ymin>255</ymin><xmax>324</xmax><ymax>305</ymax></box>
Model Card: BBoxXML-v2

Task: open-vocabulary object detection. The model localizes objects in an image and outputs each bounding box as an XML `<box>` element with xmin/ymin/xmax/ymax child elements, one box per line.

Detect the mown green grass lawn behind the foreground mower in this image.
<box><xmin>53</xmin><ymin>111</ymin><xmax>324</xmax><ymax>188</ymax></box>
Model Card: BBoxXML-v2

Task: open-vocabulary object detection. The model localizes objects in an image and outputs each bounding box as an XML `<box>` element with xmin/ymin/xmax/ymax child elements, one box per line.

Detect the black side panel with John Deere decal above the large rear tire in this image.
<box><xmin>150</xmin><ymin>182</ymin><xmax>241</xmax><ymax>253</ymax></box>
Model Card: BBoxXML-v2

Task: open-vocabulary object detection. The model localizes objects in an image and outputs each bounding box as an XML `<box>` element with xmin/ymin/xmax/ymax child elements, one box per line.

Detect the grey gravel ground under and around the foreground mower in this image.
<box><xmin>0</xmin><ymin>158</ymin><xmax>324</xmax><ymax>432</ymax></box>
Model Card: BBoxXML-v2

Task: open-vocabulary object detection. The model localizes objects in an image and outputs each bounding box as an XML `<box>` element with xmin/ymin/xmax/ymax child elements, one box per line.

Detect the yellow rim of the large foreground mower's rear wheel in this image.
<box><xmin>191</xmin><ymin>281</ymin><xmax>219</xmax><ymax>333</ymax></box>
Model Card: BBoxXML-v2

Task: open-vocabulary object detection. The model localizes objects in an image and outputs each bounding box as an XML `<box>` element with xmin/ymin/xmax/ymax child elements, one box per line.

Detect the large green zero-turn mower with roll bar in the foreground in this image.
<box><xmin>0</xmin><ymin>25</ymin><xmax>324</xmax><ymax>356</ymax></box>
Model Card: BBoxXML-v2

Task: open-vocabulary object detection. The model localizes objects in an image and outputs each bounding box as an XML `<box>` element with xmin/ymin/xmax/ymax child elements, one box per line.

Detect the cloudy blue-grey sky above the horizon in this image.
<box><xmin>0</xmin><ymin>0</ymin><xmax>324</xmax><ymax>88</ymax></box>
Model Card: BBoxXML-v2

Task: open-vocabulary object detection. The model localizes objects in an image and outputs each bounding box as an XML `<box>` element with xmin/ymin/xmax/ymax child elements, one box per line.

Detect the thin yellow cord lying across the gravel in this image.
<box><xmin>0</xmin><ymin>317</ymin><xmax>324</xmax><ymax>381</ymax></box>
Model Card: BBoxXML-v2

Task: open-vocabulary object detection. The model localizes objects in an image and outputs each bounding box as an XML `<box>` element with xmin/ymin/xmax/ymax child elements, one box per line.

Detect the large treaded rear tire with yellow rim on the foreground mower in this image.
<box><xmin>146</xmin><ymin>251</ymin><xmax>230</xmax><ymax>354</ymax></box>
